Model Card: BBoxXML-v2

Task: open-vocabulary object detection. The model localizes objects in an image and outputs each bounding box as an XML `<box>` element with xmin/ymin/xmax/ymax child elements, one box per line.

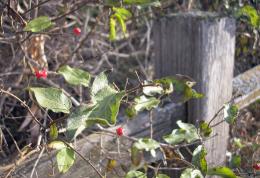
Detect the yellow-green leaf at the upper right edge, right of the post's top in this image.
<box><xmin>238</xmin><ymin>5</ymin><xmax>260</xmax><ymax>28</ymax></box>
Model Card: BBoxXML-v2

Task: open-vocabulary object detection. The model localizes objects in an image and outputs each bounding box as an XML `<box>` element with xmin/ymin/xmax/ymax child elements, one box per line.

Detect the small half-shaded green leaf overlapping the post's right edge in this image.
<box><xmin>224</xmin><ymin>103</ymin><xmax>238</xmax><ymax>124</ymax></box>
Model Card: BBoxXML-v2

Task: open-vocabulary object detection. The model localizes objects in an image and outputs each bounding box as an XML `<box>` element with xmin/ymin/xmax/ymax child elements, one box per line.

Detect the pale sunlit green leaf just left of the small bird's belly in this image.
<box><xmin>133</xmin><ymin>95</ymin><xmax>160</xmax><ymax>112</ymax></box>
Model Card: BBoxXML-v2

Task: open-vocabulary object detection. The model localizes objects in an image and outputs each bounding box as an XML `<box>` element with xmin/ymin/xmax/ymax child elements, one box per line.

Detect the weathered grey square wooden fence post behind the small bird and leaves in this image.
<box><xmin>153</xmin><ymin>12</ymin><xmax>235</xmax><ymax>166</ymax></box>
